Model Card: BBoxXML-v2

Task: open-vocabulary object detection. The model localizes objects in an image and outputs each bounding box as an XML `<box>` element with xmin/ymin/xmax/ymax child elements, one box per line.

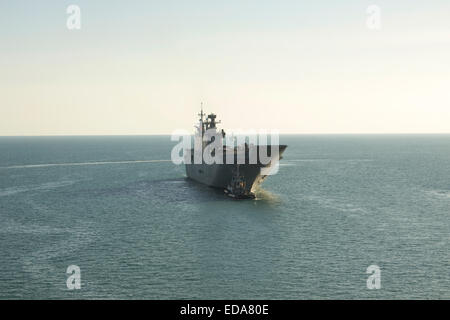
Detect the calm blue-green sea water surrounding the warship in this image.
<box><xmin>0</xmin><ymin>135</ymin><xmax>450</xmax><ymax>299</ymax></box>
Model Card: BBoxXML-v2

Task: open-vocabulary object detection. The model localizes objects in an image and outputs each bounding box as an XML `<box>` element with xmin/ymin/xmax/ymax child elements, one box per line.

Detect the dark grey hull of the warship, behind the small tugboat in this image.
<box><xmin>186</xmin><ymin>145</ymin><xmax>286</xmax><ymax>192</ymax></box>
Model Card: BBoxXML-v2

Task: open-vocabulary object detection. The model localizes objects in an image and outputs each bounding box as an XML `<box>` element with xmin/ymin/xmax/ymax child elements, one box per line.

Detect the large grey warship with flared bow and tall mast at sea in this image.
<box><xmin>185</xmin><ymin>108</ymin><xmax>287</xmax><ymax>199</ymax></box>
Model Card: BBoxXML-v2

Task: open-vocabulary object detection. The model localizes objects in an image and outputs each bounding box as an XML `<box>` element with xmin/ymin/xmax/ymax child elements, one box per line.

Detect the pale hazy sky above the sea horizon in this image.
<box><xmin>0</xmin><ymin>0</ymin><xmax>450</xmax><ymax>135</ymax></box>
